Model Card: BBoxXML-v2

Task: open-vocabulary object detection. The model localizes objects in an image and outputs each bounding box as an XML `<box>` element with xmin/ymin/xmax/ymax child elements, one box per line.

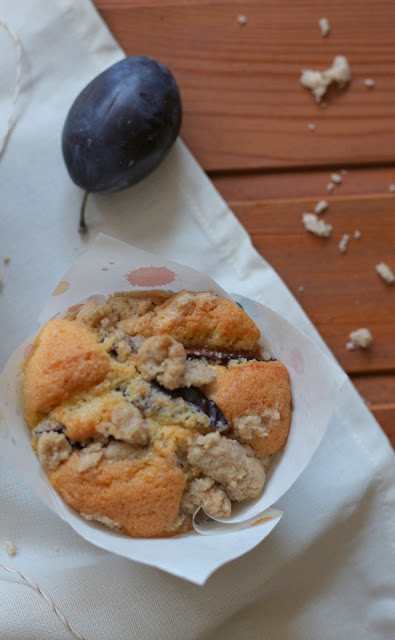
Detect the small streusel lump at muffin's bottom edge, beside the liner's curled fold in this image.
<box><xmin>181</xmin><ymin>478</ymin><xmax>232</xmax><ymax>518</ymax></box>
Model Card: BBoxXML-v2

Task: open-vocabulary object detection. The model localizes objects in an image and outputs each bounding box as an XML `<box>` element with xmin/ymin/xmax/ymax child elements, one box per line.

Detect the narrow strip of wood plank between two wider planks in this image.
<box><xmin>213</xmin><ymin>167</ymin><xmax>395</xmax><ymax>205</ymax></box>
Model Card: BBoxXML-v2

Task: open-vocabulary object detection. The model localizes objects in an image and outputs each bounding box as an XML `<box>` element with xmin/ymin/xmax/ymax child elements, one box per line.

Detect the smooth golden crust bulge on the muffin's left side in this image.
<box><xmin>23</xmin><ymin>318</ymin><xmax>110</xmax><ymax>427</ymax></box>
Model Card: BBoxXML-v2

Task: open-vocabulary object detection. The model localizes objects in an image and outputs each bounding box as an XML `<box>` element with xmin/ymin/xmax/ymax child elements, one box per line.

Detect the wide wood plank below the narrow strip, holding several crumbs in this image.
<box><xmin>230</xmin><ymin>195</ymin><xmax>395</xmax><ymax>373</ymax></box>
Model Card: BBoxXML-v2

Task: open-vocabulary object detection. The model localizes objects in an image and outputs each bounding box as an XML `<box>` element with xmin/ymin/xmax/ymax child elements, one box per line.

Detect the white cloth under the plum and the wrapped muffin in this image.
<box><xmin>0</xmin><ymin>0</ymin><xmax>395</xmax><ymax>640</ymax></box>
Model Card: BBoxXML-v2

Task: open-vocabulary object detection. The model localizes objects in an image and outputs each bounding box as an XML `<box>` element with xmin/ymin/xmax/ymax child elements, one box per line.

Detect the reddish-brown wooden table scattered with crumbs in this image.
<box><xmin>95</xmin><ymin>0</ymin><xmax>395</xmax><ymax>447</ymax></box>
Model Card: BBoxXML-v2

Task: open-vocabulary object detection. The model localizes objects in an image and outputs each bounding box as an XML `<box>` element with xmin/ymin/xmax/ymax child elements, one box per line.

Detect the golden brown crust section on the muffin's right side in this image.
<box><xmin>205</xmin><ymin>361</ymin><xmax>291</xmax><ymax>458</ymax></box>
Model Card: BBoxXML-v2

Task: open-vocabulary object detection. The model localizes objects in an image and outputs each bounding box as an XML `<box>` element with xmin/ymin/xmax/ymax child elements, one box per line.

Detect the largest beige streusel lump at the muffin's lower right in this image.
<box><xmin>188</xmin><ymin>431</ymin><xmax>265</xmax><ymax>501</ymax></box>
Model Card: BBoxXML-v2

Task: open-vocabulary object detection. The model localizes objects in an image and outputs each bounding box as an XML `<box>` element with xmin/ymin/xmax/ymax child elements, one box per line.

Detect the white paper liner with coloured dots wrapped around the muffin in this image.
<box><xmin>0</xmin><ymin>234</ymin><xmax>346</xmax><ymax>584</ymax></box>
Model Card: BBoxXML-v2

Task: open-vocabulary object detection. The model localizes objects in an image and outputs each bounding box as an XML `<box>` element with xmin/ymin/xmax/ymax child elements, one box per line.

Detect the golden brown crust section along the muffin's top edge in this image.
<box><xmin>122</xmin><ymin>291</ymin><xmax>260</xmax><ymax>351</ymax></box>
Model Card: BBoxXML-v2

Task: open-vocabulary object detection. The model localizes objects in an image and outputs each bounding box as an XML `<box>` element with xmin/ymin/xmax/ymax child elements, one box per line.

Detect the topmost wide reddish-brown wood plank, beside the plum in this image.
<box><xmin>96</xmin><ymin>0</ymin><xmax>395</xmax><ymax>170</ymax></box>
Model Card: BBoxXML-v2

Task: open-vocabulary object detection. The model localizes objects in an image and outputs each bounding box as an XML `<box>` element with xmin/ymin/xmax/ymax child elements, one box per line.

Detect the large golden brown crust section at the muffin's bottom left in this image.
<box><xmin>48</xmin><ymin>451</ymin><xmax>185</xmax><ymax>538</ymax></box>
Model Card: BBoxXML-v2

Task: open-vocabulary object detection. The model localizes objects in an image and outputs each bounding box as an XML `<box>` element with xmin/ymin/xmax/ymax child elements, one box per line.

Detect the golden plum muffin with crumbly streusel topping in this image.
<box><xmin>23</xmin><ymin>291</ymin><xmax>291</xmax><ymax>537</ymax></box>
